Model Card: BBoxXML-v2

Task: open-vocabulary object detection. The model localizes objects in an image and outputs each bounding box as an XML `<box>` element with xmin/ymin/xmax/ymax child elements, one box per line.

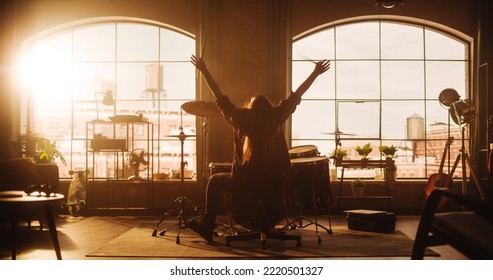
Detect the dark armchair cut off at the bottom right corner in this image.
<box><xmin>411</xmin><ymin>189</ymin><xmax>493</xmax><ymax>260</ymax></box>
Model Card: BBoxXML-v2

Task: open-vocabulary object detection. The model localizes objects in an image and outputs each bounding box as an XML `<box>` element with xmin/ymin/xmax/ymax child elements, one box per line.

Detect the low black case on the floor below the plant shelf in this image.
<box><xmin>344</xmin><ymin>209</ymin><xmax>396</xmax><ymax>232</ymax></box>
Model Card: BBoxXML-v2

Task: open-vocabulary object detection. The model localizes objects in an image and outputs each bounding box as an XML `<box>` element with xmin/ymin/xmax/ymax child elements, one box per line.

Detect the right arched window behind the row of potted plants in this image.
<box><xmin>292</xmin><ymin>20</ymin><xmax>470</xmax><ymax>178</ymax></box>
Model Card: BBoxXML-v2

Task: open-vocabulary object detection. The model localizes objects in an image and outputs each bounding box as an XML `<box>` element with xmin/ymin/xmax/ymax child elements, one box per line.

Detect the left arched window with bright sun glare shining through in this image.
<box><xmin>21</xmin><ymin>18</ymin><xmax>196</xmax><ymax>177</ymax></box>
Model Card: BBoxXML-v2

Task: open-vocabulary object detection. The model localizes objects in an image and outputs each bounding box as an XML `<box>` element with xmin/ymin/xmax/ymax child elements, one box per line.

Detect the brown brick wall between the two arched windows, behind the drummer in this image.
<box><xmin>208</xmin><ymin>0</ymin><xmax>271</xmax><ymax>162</ymax></box>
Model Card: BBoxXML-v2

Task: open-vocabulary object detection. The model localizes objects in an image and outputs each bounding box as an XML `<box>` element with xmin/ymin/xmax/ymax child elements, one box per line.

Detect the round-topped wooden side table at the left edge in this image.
<box><xmin>0</xmin><ymin>191</ymin><xmax>64</xmax><ymax>260</ymax></box>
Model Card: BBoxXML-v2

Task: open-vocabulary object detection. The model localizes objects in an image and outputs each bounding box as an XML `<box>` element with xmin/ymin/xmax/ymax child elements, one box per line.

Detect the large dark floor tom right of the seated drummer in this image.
<box><xmin>287</xmin><ymin>156</ymin><xmax>332</xmax><ymax>211</ymax></box>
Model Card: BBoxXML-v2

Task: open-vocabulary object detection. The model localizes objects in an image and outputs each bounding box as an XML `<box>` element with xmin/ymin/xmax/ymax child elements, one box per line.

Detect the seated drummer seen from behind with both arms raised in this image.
<box><xmin>188</xmin><ymin>55</ymin><xmax>330</xmax><ymax>241</ymax></box>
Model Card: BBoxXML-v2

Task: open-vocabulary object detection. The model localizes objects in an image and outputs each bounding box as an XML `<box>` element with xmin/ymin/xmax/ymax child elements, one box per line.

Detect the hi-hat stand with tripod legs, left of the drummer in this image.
<box><xmin>152</xmin><ymin>108</ymin><xmax>197</xmax><ymax>244</ymax></box>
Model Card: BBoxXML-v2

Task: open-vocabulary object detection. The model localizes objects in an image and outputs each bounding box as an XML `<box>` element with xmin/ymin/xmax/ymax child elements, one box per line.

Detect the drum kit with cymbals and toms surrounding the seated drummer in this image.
<box><xmin>152</xmin><ymin>101</ymin><xmax>338</xmax><ymax>244</ymax></box>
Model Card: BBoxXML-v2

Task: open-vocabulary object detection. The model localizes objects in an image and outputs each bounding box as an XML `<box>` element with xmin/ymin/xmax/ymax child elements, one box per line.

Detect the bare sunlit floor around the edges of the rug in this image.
<box><xmin>0</xmin><ymin>215</ymin><xmax>467</xmax><ymax>260</ymax></box>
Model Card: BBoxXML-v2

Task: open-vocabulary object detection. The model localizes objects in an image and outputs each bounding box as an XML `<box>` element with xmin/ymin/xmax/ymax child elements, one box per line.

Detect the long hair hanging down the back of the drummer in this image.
<box><xmin>243</xmin><ymin>94</ymin><xmax>278</xmax><ymax>168</ymax></box>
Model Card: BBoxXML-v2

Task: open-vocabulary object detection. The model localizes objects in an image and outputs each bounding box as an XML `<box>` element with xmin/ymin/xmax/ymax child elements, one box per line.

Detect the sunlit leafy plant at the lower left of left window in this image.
<box><xmin>12</xmin><ymin>133</ymin><xmax>67</xmax><ymax>165</ymax></box>
